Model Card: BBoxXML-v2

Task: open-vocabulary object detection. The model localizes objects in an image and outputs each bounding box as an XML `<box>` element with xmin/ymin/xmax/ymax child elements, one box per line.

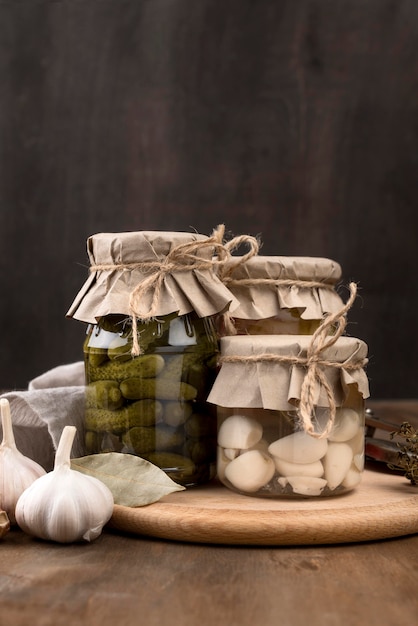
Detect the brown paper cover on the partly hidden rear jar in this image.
<box><xmin>221</xmin><ymin>256</ymin><xmax>342</xmax><ymax>320</ymax></box>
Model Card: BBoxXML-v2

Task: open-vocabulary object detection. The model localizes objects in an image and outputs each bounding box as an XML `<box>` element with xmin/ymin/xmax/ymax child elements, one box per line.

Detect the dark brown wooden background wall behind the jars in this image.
<box><xmin>0</xmin><ymin>0</ymin><xmax>418</xmax><ymax>398</ymax></box>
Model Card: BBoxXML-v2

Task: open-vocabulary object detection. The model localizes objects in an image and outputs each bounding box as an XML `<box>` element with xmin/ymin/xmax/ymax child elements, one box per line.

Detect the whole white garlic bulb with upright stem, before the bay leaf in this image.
<box><xmin>16</xmin><ymin>426</ymin><xmax>113</xmax><ymax>543</ymax></box>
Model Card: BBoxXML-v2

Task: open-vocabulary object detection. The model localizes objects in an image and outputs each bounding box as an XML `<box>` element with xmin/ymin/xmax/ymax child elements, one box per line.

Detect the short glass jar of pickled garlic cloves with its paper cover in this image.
<box><xmin>208</xmin><ymin>335</ymin><xmax>368</xmax><ymax>498</ymax></box>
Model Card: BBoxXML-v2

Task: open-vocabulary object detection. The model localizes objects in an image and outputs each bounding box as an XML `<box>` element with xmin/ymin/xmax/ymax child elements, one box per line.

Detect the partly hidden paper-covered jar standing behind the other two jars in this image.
<box><xmin>218</xmin><ymin>256</ymin><xmax>343</xmax><ymax>336</ymax></box>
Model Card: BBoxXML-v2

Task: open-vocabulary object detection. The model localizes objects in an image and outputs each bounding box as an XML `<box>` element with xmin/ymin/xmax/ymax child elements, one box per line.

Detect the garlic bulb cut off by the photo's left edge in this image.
<box><xmin>0</xmin><ymin>398</ymin><xmax>46</xmax><ymax>524</ymax></box>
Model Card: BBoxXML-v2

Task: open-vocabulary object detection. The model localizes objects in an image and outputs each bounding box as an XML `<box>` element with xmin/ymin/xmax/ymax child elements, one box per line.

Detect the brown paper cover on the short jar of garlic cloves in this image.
<box><xmin>208</xmin><ymin>335</ymin><xmax>369</xmax><ymax>411</ymax></box>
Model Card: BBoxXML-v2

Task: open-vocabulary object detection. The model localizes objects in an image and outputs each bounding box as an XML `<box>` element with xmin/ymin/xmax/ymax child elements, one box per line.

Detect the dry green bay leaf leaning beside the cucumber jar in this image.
<box><xmin>71</xmin><ymin>452</ymin><xmax>185</xmax><ymax>507</ymax></box>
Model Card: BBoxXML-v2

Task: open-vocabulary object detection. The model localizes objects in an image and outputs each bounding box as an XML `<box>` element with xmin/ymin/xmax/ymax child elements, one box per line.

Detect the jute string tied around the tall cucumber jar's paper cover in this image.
<box><xmin>90</xmin><ymin>224</ymin><xmax>259</xmax><ymax>356</ymax></box>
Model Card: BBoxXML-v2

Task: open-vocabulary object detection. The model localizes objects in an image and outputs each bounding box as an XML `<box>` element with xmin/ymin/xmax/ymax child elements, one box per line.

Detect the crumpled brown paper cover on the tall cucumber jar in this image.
<box><xmin>67</xmin><ymin>231</ymin><xmax>238</xmax><ymax>324</ymax></box>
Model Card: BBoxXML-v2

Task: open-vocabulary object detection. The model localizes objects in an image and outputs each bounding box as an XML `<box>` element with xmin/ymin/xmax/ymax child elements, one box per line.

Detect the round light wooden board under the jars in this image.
<box><xmin>109</xmin><ymin>470</ymin><xmax>418</xmax><ymax>545</ymax></box>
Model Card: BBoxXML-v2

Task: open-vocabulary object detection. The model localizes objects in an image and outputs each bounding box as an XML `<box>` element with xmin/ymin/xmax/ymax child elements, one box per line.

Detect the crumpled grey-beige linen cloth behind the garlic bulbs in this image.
<box><xmin>1</xmin><ymin>361</ymin><xmax>85</xmax><ymax>471</ymax></box>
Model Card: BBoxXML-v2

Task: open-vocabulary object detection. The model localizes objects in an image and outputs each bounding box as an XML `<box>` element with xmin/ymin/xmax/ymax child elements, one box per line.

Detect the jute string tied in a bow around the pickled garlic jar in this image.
<box><xmin>220</xmin><ymin>283</ymin><xmax>367</xmax><ymax>439</ymax></box>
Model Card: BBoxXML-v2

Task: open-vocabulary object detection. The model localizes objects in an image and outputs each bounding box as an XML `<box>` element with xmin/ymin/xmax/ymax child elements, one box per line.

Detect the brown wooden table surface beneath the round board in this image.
<box><xmin>0</xmin><ymin>400</ymin><xmax>418</xmax><ymax>626</ymax></box>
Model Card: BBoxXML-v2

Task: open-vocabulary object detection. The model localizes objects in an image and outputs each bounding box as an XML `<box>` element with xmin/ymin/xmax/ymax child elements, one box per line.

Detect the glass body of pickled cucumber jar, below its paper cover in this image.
<box><xmin>84</xmin><ymin>314</ymin><xmax>218</xmax><ymax>484</ymax></box>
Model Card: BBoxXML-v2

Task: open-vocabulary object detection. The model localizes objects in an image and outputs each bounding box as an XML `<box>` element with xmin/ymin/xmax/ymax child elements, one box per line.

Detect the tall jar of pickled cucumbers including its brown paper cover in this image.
<box><xmin>67</xmin><ymin>231</ymin><xmax>240</xmax><ymax>486</ymax></box>
